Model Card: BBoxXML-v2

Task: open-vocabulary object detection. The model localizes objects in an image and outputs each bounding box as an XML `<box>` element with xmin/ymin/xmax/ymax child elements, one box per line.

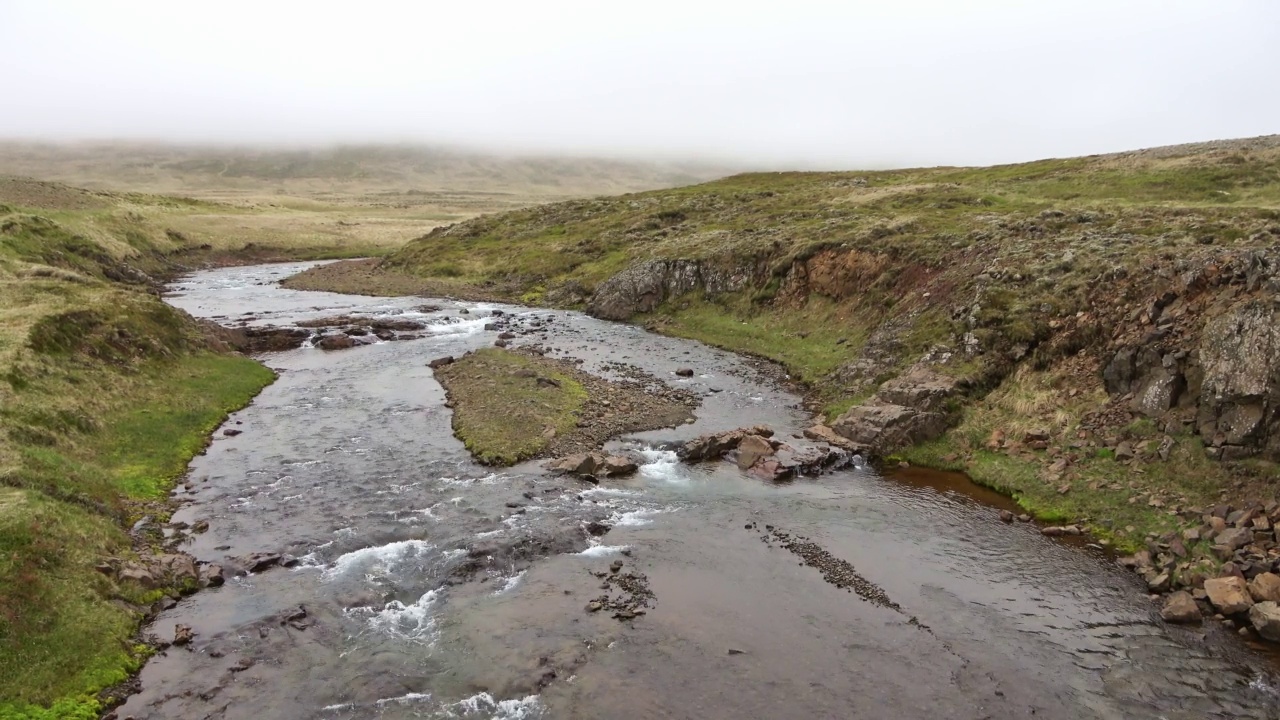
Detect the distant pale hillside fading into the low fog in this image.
<box><xmin>0</xmin><ymin>142</ymin><xmax>727</xmax><ymax>201</ymax></box>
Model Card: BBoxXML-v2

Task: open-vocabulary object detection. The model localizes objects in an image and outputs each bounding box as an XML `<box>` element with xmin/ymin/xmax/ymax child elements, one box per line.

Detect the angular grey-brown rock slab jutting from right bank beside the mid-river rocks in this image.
<box><xmin>831</xmin><ymin>368</ymin><xmax>957</xmax><ymax>455</ymax></box>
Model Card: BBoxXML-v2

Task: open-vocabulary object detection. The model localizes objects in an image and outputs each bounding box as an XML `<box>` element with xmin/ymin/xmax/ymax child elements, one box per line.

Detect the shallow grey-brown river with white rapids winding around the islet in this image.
<box><xmin>118</xmin><ymin>264</ymin><xmax>1280</xmax><ymax>720</ymax></box>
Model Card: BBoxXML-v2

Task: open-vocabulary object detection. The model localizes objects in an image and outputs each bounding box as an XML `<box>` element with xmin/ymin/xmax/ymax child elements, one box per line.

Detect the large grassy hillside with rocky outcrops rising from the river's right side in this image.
<box><xmin>289</xmin><ymin>136</ymin><xmax>1280</xmax><ymax>571</ymax></box>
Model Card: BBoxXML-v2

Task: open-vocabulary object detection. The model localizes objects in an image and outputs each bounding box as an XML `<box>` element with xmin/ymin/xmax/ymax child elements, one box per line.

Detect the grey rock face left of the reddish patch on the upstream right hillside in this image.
<box><xmin>586</xmin><ymin>259</ymin><xmax>756</xmax><ymax>320</ymax></box>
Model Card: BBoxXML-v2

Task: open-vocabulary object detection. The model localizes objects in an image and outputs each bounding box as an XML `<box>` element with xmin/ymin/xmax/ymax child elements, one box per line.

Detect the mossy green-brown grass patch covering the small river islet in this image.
<box><xmin>435</xmin><ymin>348</ymin><xmax>586</xmax><ymax>465</ymax></box>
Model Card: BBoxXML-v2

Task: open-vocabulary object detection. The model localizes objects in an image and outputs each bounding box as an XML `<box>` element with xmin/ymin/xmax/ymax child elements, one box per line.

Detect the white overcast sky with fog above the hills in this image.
<box><xmin>0</xmin><ymin>0</ymin><xmax>1280</xmax><ymax>168</ymax></box>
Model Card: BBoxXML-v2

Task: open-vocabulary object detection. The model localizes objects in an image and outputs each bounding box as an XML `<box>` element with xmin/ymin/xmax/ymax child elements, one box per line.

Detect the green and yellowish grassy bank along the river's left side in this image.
<box><xmin>0</xmin><ymin>184</ymin><xmax>282</xmax><ymax>719</ymax></box>
